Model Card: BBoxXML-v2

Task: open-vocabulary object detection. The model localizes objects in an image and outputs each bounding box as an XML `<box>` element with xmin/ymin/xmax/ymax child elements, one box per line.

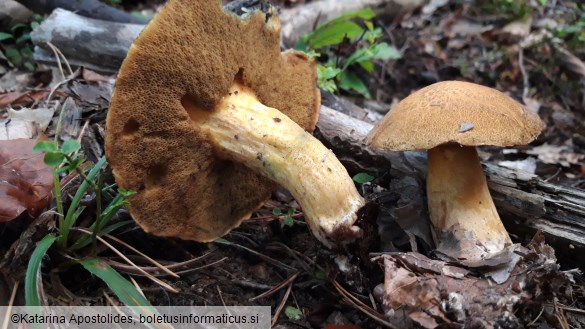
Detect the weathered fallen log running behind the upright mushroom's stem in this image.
<box><xmin>316</xmin><ymin>106</ymin><xmax>585</xmax><ymax>267</ymax></box>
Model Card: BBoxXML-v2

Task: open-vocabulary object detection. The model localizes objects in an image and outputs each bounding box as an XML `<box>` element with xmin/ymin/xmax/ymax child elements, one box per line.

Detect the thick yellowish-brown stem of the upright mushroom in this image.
<box><xmin>427</xmin><ymin>144</ymin><xmax>512</xmax><ymax>260</ymax></box>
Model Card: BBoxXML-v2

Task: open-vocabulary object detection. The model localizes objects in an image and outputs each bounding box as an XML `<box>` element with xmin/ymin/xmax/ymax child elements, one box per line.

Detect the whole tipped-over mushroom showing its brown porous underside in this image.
<box><xmin>106</xmin><ymin>0</ymin><xmax>364</xmax><ymax>246</ymax></box>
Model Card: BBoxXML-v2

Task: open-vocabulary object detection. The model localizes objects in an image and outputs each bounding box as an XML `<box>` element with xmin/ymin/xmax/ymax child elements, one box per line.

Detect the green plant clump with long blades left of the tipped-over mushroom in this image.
<box><xmin>25</xmin><ymin>107</ymin><xmax>150</xmax><ymax>306</ymax></box>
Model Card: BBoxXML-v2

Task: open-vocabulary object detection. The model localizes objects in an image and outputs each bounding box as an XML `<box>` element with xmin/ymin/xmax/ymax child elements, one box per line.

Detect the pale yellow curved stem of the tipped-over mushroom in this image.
<box><xmin>183</xmin><ymin>83</ymin><xmax>365</xmax><ymax>247</ymax></box>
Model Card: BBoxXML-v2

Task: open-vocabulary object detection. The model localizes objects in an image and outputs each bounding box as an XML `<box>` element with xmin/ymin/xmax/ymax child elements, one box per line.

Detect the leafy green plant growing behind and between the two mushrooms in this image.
<box><xmin>295</xmin><ymin>9</ymin><xmax>401</xmax><ymax>98</ymax></box>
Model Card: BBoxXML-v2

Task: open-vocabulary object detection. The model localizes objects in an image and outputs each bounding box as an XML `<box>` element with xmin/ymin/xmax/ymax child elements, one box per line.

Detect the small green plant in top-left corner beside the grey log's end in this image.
<box><xmin>0</xmin><ymin>15</ymin><xmax>44</xmax><ymax>71</ymax></box>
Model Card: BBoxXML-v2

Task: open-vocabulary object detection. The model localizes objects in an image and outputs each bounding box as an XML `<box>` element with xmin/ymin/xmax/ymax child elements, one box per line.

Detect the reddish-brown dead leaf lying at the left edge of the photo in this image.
<box><xmin>0</xmin><ymin>135</ymin><xmax>53</xmax><ymax>222</ymax></box>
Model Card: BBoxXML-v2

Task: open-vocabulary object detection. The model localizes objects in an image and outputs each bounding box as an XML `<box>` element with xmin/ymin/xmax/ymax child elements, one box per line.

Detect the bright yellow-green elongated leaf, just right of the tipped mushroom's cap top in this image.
<box><xmin>307</xmin><ymin>21</ymin><xmax>364</xmax><ymax>49</ymax></box>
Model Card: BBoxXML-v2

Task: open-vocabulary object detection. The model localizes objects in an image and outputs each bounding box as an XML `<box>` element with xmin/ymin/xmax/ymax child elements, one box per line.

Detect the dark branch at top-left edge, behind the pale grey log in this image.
<box><xmin>16</xmin><ymin>0</ymin><xmax>147</xmax><ymax>24</ymax></box>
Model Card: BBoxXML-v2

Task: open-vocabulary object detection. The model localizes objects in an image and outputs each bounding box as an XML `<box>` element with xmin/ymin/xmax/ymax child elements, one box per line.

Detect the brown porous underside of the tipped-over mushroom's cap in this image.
<box><xmin>106</xmin><ymin>0</ymin><xmax>320</xmax><ymax>241</ymax></box>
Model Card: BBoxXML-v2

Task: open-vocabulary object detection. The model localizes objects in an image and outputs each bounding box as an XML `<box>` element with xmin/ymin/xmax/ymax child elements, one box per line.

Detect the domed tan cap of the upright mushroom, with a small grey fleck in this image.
<box><xmin>366</xmin><ymin>81</ymin><xmax>544</xmax><ymax>151</ymax></box>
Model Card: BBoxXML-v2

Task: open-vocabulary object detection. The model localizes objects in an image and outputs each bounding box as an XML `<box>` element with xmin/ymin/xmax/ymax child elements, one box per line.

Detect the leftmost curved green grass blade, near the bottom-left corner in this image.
<box><xmin>24</xmin><ymin>234</ymin><xmax>57</xmax><ymax>306</ymax></box>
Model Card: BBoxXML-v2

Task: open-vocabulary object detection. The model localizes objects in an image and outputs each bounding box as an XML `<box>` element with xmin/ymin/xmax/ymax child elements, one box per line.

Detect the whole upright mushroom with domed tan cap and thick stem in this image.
<box><xmin>366</xmin><ymin>81</ymin><xmax>544</xmax><ymax>260</ymax></box>
